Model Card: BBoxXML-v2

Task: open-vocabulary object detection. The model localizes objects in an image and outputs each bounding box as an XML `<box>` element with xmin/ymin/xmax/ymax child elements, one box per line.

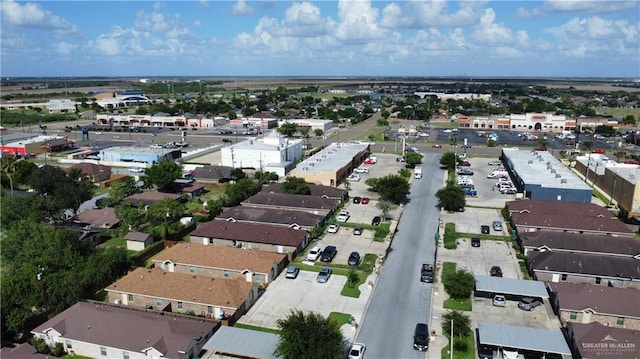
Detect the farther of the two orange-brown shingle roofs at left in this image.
<box><xmin>153</xmin><ymin>243</ymin><xmax>286</xmax><ymax>273</ymax></box>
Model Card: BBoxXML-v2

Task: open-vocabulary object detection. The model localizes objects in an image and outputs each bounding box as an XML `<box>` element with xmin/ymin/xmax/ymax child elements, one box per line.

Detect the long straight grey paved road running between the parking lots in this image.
<box><xmin>357</xmin><ymin>154</ymin><xmax>443</xmax><ymax>359</ymax></box>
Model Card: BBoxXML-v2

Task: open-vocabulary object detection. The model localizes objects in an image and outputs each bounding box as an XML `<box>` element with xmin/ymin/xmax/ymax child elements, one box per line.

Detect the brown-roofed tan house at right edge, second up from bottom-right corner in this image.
<box><xmin>549</xmin><ymin>283</ymin><xmax>640</xmax><ymax>330</ymax></box>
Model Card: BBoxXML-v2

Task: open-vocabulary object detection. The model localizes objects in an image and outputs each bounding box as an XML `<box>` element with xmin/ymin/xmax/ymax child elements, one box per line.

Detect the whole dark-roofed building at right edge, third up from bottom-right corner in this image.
<box><xmin>527</xmin><ymin>251</ymin><xmax>640</xmax><ymax>288</ymax></box>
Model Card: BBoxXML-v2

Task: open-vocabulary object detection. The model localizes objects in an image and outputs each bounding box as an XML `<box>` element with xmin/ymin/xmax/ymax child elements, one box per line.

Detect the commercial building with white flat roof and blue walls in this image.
<box><xmin>502</xmin><ymin>148</ymin><xmax>592</xmax><ymax>203</ymax></box>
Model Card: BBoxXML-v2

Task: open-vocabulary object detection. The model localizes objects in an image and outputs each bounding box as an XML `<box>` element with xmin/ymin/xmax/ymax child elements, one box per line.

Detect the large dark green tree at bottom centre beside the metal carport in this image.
<box><xmin>273</xmin><ymin>310</ymin><xmax>344</xmax><ymax>359</ymax></box>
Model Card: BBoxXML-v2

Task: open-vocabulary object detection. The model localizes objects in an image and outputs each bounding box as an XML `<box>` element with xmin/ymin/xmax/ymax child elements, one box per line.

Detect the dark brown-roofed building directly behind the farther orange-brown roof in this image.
<box><xmin>189</xmin><ymin>221</ymin><xmax>310</xmax><ymax>257</ymax></box>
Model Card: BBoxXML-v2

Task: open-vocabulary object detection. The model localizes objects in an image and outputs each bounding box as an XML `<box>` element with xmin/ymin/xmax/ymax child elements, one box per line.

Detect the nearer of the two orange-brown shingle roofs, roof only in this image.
<box><xmin>105</xmin><ymin>268</ymin><xmax>253</xmax><ymax>309</ymax></box>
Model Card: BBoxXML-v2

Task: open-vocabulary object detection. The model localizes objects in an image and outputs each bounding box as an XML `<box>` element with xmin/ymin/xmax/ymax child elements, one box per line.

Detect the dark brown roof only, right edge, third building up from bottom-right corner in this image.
<box><xmin>529</xmin><ymin>251</ymin><xmax>640</xmax><ymax>280</ymax></box>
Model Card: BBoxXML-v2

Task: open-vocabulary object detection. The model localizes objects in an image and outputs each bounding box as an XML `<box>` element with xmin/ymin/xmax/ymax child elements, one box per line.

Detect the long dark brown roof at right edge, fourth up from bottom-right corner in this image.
<box><xmin>519</xmin><ymin>231</ymin><xmax>640</xmax><ymax>257</ymax></box>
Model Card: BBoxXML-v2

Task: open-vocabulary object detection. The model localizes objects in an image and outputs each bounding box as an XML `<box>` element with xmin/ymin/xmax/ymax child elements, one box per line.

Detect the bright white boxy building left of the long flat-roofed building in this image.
<box><xmin>221</xmin><ymin>131</ymin><xmax>302</xmax><ymax>176</ymax></box>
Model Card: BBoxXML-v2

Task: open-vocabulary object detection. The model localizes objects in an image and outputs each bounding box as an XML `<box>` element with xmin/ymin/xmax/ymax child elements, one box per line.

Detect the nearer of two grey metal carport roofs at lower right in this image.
<box><xmin>478</xmin><ymin>322</ymin><xmax>571</xmax><ymax>355</ymax></box>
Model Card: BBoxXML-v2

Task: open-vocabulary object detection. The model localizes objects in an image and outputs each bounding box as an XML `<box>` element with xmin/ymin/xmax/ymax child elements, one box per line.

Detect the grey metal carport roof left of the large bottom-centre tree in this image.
<box><xmin>203</xmin><ymin>326</ymin><xmax>280</xmax><ymax>359</ymax></box>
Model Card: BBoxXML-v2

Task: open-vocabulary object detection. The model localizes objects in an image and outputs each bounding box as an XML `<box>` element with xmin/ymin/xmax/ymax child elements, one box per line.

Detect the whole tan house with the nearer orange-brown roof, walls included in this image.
<box><xmin>105</xmin><ymin>268</ymin><xmax>258</xmax><ymax>322</ymax></box>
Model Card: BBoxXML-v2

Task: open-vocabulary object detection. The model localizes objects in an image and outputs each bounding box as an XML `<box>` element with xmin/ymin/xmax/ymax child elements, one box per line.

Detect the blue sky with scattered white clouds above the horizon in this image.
<box><xmin>0</xmin><ymin>0</ymin><xmax>640</xmax><ymax>78</ymax></box>
